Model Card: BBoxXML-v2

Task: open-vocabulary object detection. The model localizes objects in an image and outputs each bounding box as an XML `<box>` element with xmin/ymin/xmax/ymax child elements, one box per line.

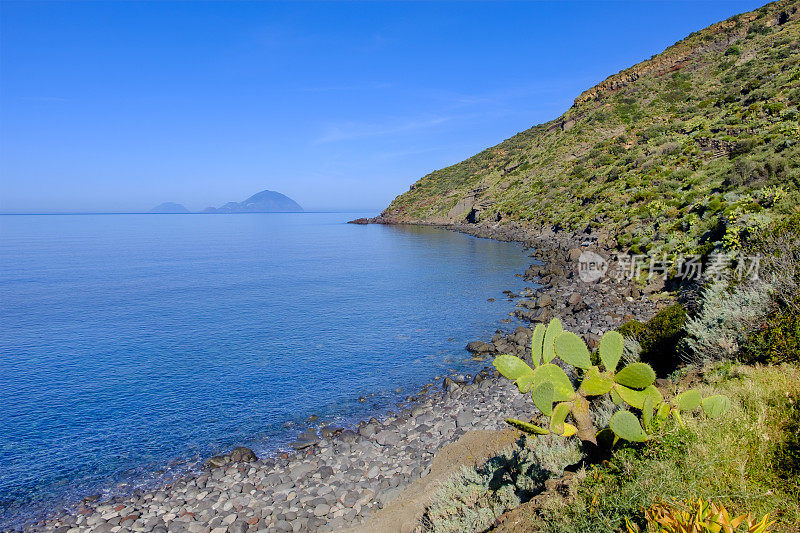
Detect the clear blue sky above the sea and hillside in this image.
<box><xmin>0</xmin><ymin>0</ymin><xmax>763</xmax><ymax>212</ymax></box>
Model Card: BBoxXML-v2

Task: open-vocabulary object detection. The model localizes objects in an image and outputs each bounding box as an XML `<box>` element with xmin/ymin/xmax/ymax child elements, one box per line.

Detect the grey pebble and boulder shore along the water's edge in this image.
<box><xmin>20</xmin><ymin>221</ymin><xmax>666</xmax><ymax>533</ymax></box>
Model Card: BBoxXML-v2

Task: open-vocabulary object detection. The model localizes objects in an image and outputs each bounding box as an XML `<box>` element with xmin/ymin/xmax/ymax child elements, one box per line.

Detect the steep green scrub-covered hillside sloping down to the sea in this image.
<box><xmin>378</xmin><ymin>0</ymin><xmax>800</xmax><ymax>254</ymax></box>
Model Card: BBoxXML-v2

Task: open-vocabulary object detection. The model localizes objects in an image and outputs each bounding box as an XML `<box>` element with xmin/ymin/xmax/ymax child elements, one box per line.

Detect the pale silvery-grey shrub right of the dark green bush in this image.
<box><xmin>681</xmin><ymin>281</ymin><xmax>772</xmax><ymax>364</ymax></box>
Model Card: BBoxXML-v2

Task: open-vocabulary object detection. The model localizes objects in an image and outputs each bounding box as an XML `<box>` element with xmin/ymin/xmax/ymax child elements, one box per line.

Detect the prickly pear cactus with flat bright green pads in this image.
<box><xmin>494</xmin><ymin>318</ymin><xmax>730</xmax><ymax>445</ymax></box>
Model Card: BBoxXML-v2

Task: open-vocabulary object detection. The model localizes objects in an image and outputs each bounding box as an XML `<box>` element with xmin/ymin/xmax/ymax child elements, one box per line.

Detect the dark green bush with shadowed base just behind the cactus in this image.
<box><xmin>617</xmin><ymin>304</ymin><xmax>687</xmax><ymax>376</ymax></box>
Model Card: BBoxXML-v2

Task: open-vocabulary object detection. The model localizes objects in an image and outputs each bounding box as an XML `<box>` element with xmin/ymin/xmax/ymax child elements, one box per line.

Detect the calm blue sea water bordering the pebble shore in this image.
<box><xmin>0</xmin><ymin>213</ymin><xmax>527</xmax><ymax>526</ymax></box>
